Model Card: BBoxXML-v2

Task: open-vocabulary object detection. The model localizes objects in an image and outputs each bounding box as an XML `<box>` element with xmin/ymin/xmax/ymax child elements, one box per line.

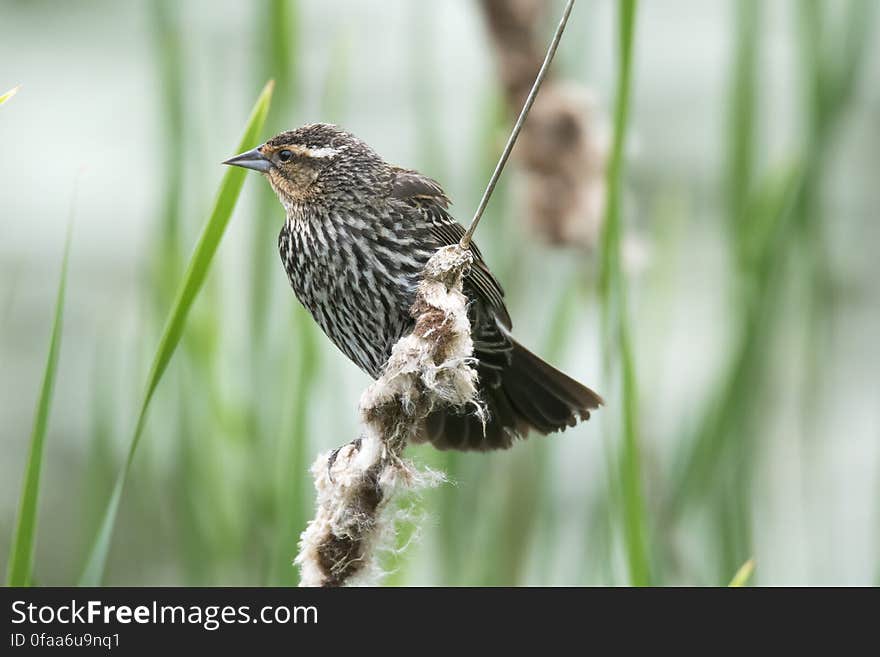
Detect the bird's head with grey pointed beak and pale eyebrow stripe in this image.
<box><xmin>223</xmin><ymin>123</ymin><xmax>381</xmax><ymax>207</ymax></box>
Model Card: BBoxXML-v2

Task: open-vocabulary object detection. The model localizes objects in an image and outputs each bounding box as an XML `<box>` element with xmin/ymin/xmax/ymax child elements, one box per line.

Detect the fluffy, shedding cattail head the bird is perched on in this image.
<box><xmin>296</xmin><ymin>246</ymin><xmax>484</xmax><ymax>586</ymax></box>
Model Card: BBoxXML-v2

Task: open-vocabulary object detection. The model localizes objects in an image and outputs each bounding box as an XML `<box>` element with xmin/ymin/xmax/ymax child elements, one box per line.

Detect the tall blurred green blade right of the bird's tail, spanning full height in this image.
<box><xmin>599</xmin><ymin>0</ymin><xmax>651</xmax><ymax>586</ymax></box>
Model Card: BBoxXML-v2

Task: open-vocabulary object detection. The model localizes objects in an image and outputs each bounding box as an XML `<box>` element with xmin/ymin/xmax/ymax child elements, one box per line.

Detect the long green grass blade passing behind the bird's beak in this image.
<box><xmin>79</xmin><ymin>81</ymin><xmax>274</xmax><ymax>586</ymax></box>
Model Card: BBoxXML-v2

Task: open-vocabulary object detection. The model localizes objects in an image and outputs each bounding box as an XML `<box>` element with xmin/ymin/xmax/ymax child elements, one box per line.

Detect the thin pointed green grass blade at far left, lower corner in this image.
<box><xmin>6</xmin><ymin>228</ymin><xmax>70</xmax><ymax>586</ymax></box>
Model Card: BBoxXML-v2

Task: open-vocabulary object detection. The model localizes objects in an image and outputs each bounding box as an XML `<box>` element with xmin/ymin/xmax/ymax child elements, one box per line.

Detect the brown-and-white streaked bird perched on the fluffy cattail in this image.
<box><xmin>224</xmin><ymin>123</ymin><xmax>603</xmax><ymax>451</ymax></box>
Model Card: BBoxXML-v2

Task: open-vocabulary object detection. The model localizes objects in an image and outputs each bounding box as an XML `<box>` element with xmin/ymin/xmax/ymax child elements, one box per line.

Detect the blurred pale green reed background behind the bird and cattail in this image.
<box><xmin>0</xmin><ymin>0</ymin><xmax>880</xmax><ymax>585</ymax></box>
